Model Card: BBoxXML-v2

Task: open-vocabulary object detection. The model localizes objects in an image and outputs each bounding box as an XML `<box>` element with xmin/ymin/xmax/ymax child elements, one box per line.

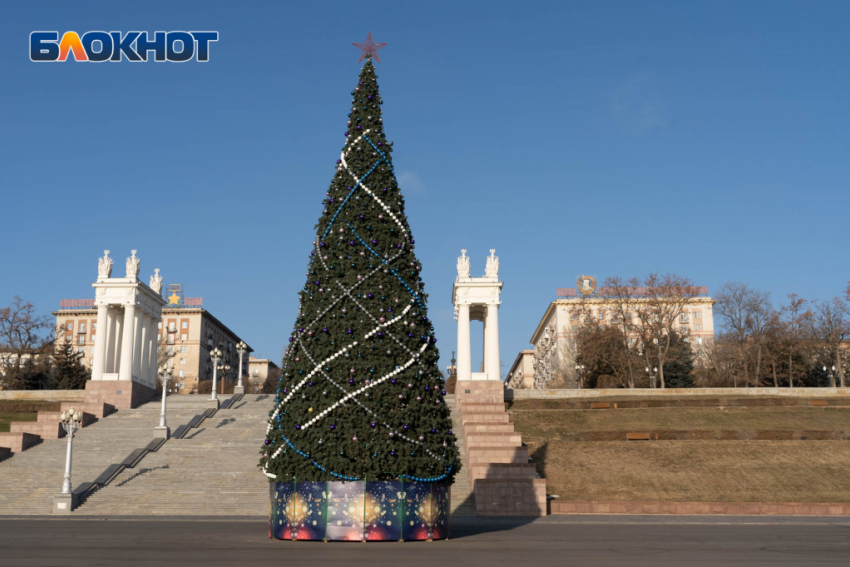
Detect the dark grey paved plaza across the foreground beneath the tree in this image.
<box><xmin>0</xmin><ymin>516</ymin><xmax>850</xmax><ymax>567</ymax></box>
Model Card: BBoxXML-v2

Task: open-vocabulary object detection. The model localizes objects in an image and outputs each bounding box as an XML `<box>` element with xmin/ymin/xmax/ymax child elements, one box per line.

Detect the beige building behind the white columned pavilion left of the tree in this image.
<box><xmin>53</xmin><ymin>286</ymin><xmax>252</xmax><ymax>394</ymax></box>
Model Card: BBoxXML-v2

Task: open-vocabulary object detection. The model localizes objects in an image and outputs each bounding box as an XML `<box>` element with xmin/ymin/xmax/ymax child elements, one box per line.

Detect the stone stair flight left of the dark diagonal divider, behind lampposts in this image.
<box><xmin>0</xmin><ymin>396</ymin><xmax>222</xmax><ymax>515</ymax></box>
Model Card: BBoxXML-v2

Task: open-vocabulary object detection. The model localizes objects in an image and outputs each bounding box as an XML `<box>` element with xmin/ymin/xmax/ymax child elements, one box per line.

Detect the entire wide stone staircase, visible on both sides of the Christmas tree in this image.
<box><xmin>0</xmin><ymin>395</ymin><xmax>475</xmax><ymax>516</ymax></box>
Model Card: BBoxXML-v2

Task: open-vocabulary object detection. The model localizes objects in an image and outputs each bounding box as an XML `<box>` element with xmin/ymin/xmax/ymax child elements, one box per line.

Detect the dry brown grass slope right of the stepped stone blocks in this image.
<box><xmin>511</xmin><ymin>407</ymin><xmax>850</xmax><ymax>502</ymax></box>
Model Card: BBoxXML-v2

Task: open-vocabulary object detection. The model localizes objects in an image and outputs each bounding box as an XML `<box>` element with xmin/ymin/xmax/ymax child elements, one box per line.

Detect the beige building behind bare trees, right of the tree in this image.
<box><xmin>520</xmin><ymin>276</ymin><xmax>716</xmax><ymax>388</ymax></box>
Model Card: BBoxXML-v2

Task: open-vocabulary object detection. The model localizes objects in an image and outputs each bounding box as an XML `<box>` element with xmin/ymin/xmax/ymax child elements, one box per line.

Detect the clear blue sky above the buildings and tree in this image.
<box><xmin>0</xmin><ymin>0</ymin><xmax>850</xmax><ymax>374</ymax></box>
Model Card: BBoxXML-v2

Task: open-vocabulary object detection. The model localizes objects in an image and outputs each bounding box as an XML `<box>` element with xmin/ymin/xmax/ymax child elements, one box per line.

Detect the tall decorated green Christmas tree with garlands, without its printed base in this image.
<box><xmin>260</xmin><ymin>52</ymin><xmax>460</xmax><ymax>483</ymax></box>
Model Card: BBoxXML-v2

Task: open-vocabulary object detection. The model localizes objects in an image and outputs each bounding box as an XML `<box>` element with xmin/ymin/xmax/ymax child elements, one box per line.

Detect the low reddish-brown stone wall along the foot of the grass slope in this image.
<box><xmin>550</xmin><ymin>500</ymin><xmax>850</xmax><ymax>516</ymax></box>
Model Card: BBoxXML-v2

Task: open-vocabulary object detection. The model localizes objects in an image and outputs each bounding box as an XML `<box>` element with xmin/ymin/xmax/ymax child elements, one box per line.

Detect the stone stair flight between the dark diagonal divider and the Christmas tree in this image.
<box><xmin>74</xmin><ymin>395</ymin><xmax>274</xmax><ymax>516</ymax></box>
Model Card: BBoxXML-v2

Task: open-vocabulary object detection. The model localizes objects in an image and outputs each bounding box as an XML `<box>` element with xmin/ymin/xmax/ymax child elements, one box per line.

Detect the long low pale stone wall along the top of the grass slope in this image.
<box><xmin>506</xmin><ymin>386</ymin><xmax>850</xmax><ymax>401</ymax></box>
